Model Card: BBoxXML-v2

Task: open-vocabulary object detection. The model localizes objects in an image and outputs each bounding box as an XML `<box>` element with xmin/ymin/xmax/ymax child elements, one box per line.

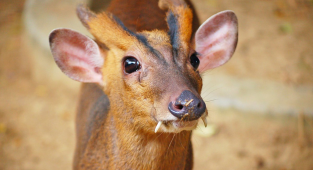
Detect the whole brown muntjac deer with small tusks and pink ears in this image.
<box><xmin>49</xmin><ymin>0</ymin><xmax>238</xmax><ymax>170</ymax></box>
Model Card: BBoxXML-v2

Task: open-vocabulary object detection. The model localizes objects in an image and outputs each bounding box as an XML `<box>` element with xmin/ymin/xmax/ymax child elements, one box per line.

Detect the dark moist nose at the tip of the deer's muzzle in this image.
<box><xmin>168</xmin><ymin>90</ymin><xmax>206</xmax><ymax>121</ymax></box>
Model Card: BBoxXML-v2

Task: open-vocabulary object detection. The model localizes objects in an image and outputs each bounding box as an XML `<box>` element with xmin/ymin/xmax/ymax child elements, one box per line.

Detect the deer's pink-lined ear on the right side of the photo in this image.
<box><xmin>195</xmin><ymin>11</ymin><xmax>238</xmax><ymax>73</ymax></box>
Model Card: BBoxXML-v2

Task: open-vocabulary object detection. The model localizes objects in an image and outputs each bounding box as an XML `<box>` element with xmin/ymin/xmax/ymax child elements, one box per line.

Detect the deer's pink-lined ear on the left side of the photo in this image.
<box><xmin>49</xmin><ymin>29</ymin><xmax>104</xmax><ymax>85</ymax></box>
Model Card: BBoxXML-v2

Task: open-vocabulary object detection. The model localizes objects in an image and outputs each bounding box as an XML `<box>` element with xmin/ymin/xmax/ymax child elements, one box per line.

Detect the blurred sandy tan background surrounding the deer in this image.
<box><xmin>0</xmin><ymin>0</ymin><xmax>313</xmax><ymax>170</ymax></box>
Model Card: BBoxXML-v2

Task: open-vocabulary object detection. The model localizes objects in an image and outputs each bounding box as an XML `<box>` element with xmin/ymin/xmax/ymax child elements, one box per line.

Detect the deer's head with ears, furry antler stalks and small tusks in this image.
<box><xmin>50</xmin><ymin>1</ymin><xmax>237</xmax><ymax>133</ymax></box>
